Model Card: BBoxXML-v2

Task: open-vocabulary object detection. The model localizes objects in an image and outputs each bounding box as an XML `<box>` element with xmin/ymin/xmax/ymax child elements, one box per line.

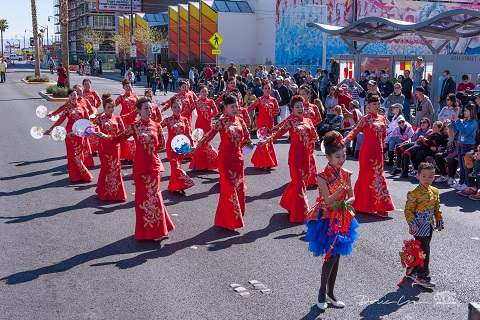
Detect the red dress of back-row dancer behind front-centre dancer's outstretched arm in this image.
<box><xmin>188</xmin><ymin>98</ymin><xmax>218</xmax><ymax>170</ymax></box>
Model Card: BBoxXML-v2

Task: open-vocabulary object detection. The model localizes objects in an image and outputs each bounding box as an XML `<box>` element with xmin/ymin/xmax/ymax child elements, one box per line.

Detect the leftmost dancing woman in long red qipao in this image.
<box><xmin>45</xmin><ymin>89</ymin><xmax>93</xmax><ymax>182</ymax></box>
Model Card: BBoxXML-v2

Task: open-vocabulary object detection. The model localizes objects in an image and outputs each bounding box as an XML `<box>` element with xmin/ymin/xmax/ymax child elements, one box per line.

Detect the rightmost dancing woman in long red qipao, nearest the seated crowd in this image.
<box><xmin>344</xmin><ymin>94</ymin><xmax>395</xmax><ymax>217</ymax></box>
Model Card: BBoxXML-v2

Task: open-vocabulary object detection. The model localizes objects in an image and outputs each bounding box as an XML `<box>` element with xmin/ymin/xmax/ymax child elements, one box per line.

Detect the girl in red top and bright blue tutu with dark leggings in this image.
<box><xmin>305</xmin><ymin>131</ymin><xmax>358</xmax><ymax>310</ymax></box>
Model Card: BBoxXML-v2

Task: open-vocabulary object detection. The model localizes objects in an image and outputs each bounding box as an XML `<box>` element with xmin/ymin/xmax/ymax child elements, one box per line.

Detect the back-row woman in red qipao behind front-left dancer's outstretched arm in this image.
<box><xmin>115</xmin><ymin>79</ymin><xmax>138</xmax><ymax>161</ymax></box>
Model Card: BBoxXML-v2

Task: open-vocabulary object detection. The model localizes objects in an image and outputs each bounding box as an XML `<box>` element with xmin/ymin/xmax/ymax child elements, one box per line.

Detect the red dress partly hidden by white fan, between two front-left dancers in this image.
<box><xmin>160</xmin><ymin>114</ymin><xmax>195</xmax><ymax>191</ymax></box>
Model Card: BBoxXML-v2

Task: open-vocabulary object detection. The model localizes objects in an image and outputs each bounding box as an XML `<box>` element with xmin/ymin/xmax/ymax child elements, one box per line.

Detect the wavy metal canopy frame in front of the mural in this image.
<box><xmin>307</xmin><ymin>9</ymin><xmax>480</xmax><ymax>54</ymax></box>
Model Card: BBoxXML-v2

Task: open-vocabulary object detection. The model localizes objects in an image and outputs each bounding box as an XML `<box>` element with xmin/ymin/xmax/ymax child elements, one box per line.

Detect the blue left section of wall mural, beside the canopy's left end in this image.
<box><xmin>275</xmin><ymin>0</ymin><xmax>353</xmax><ymax>66</ymax></box>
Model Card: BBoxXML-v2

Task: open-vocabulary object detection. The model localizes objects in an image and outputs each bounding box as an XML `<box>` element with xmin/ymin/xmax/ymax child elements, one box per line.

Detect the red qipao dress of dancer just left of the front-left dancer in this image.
<box><xmin>93</xmin><ymin>113</ymin><xmax>127</xmax><ymax>201</ymax></box>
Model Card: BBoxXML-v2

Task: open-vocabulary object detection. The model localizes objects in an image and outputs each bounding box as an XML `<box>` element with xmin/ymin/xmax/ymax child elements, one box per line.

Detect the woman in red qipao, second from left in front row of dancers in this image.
<box><xmin>193</xmin><ymin>96</ymin><xmax>250</xmax><ymax>229</ymax></box>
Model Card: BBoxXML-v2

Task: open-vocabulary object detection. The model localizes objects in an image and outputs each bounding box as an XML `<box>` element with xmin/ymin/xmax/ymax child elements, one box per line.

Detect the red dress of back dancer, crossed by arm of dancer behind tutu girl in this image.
<box><xmin>247</xmin><ymin>96</ymin><xmax>280</xmax><ymax>168</ymax></box>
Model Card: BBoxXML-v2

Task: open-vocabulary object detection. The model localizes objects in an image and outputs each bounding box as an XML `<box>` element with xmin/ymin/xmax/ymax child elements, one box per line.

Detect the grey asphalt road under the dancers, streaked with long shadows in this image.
<box><xmin>0</xmin><ymin>63</ymin><xmax>480</xmax><ymax>320</ymax></box>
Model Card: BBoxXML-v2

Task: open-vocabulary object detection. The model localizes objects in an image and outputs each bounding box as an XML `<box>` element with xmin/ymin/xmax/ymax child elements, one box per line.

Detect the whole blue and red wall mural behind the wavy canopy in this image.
<box><xmin>275</xmin><ymin>0</ymin><xmax>480</xmax><ymax>65</ymax></box>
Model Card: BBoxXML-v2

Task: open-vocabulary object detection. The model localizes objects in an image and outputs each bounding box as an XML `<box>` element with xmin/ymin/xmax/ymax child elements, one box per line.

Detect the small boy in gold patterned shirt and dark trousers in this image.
<box><xmin>404</xmin><ymin>162</ymin><xmax>443</xmax><ymax>288</ymax></box>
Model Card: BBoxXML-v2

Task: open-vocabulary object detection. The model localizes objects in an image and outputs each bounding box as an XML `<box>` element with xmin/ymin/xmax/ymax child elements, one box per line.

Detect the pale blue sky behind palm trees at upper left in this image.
<box><xmin>0</xmin><ymin>0</ymin><xmax>55</xmax><ymax>48</ymax></box>
